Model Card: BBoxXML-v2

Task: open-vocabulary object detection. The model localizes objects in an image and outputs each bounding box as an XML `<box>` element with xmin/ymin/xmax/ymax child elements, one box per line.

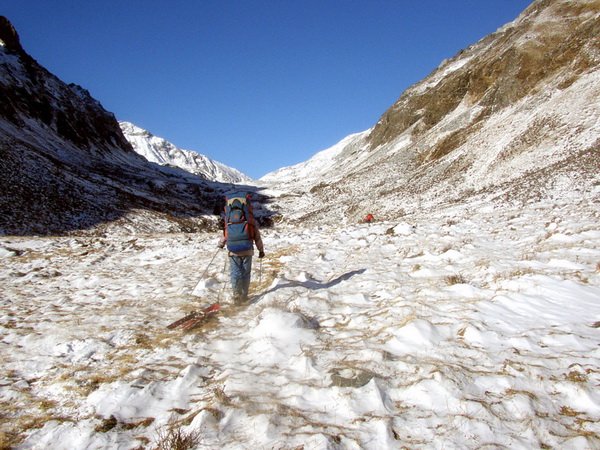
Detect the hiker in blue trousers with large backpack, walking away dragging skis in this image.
<box><xmin>219</xmin><ymin>193</ymin><xmax>265</xmax><ymax>305</ymax></box>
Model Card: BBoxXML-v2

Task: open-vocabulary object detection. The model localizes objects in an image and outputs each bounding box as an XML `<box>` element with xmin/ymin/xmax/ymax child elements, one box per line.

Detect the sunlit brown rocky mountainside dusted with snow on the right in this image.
<box><xmin>262</xmin><ymin>0</ymin><xmax>600</xmax><ymax>222</ymax></box>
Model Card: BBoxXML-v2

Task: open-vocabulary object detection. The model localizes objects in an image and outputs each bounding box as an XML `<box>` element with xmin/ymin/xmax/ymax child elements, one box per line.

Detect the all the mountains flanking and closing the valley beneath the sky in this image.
<box><xmin>0</xmin><ymin>0</ymin><xmax>600</xmax><ymax>234</ymax></box>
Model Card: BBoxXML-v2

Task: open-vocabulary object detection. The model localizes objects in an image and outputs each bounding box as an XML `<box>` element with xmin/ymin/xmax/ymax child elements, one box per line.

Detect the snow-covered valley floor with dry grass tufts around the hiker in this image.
<box><xmin>0</xmin><ymin>200</ymin><xmax>600</xmax><ymax>449</ymax></box>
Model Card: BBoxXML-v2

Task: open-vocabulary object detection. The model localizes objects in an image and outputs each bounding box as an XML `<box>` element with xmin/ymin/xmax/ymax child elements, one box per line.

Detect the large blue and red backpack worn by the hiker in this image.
<box><xmin>225</xmin><ymin>193</ymin><xmax>254</xmax><ymax>253</ymax></box>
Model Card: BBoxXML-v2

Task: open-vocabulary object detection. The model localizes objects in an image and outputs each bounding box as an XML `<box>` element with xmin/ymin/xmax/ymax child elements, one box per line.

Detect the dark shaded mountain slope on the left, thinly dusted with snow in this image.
<box><xmin>0</xmin><ymin>17</ymin><xmax>232</xmax><ymax>235</ymax></box>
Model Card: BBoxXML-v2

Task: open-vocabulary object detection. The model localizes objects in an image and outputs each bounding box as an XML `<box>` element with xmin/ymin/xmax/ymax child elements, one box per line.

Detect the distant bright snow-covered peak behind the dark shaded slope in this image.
<box><xmin>119</xmin><ymin>122</ymin><xmax>251</xmax><ymax>183</ymax></box>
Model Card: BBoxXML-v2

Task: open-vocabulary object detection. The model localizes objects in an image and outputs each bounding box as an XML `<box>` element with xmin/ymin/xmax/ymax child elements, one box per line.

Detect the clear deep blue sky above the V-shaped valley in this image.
<box><xmin>0</xmin><ymin>0</ymin><xmax>531</xmax><ymax>178</ymax></box>
